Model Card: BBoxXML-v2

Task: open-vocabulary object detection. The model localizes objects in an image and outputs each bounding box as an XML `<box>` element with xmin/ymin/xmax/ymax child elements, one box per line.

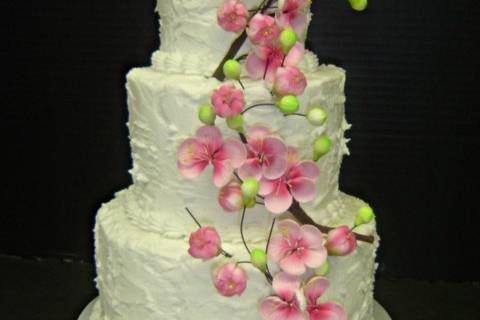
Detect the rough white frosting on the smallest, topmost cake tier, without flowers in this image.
<box><xmin>154</xmin><ymin>0</ymin><xmax>311</xmax><ymax>75</ymax></box>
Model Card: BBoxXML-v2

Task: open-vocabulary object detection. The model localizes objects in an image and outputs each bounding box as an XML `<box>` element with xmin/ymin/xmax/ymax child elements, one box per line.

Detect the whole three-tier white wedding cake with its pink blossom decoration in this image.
<box><xmin>82</xmin><ymin>0</ymin><xmax>390</xmax><ymax>320</ymax></box>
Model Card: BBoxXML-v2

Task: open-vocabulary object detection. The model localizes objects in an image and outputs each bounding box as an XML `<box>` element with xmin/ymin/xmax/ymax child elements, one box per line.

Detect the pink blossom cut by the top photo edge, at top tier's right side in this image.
<box><xmin>275</xmin><ymin>0</ymin><xmax>308</xmax><ymax>35</ymax></box>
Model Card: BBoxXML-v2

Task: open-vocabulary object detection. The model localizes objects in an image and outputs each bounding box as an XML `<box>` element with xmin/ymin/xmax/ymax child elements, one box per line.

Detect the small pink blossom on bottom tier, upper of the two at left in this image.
<box><xmin>188</xmin><ymin>227</ymin><xmax>221</xmax><ymax>260</ymax></box>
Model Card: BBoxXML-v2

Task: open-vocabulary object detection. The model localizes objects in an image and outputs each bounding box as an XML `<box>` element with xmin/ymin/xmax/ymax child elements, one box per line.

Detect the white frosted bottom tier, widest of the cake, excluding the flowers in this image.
<box><xmin>90</xmin><ymin>190</ymin><xmax>378</xmax><ymax>320</ymax></box>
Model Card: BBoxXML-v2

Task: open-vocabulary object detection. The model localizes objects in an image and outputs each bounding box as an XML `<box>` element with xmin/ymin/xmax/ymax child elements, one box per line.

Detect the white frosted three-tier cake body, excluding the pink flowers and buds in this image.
<box><xmin>79</xmin><ymin>0</ymin><xmax>386</xmax><ymax>320</ymax></box>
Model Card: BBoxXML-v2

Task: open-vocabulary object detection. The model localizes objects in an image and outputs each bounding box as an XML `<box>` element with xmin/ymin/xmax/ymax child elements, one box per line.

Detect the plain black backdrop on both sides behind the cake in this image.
<box><xmin>0</xmin><ymin>0</ymin><xmax>480</xmax><ymax>280</ymax></box>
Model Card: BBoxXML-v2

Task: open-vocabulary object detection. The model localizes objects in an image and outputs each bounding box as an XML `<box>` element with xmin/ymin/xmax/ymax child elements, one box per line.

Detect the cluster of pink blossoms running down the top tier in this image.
<box><xmin>217</xmin><ymin>0</ymin><xmax>309</xmax><ymax>94</ymax></box>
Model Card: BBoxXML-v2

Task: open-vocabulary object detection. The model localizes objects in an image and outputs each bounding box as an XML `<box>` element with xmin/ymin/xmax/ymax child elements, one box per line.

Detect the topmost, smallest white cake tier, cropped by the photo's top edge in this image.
<box><xmin>155</xmin><ymin>0</ymin><xmax>311</xmax><ymax>72</ymax></box>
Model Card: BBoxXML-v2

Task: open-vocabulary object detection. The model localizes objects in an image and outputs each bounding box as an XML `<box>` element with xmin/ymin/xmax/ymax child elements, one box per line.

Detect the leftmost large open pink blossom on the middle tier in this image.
<box><xmin>177</xmin><ymin>126</ymin><xmax>247</xmax><ymax>188</ymax></box>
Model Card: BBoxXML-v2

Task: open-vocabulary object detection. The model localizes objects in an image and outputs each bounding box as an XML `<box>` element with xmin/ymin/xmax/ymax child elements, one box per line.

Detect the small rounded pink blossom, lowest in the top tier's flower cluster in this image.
<box><xmin>273</xmin><ymin>66</ymin><xmax>307</xmax><ymax>96</ymax></box>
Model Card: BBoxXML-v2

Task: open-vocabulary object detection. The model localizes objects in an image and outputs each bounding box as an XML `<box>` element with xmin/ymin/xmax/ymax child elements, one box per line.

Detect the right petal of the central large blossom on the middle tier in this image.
<box><xmin>263</xmin><ymin>137</ymin><xmax>287</xmax><ymax>180</ymax></box>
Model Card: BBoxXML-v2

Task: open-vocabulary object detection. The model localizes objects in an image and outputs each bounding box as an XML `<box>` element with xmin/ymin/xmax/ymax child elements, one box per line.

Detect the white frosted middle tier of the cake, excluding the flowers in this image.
<box><xmin>127</xmin><ymin>66</ymin><xmax>348</xmax><ymax>239</ymax></box>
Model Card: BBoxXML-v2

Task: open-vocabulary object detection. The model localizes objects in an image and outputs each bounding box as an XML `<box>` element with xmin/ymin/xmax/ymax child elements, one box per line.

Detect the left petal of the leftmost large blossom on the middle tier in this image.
<box><xmin>177</xmin><ymin>138</ymin><xmax>209</xmax><ymax>179</ymax></box>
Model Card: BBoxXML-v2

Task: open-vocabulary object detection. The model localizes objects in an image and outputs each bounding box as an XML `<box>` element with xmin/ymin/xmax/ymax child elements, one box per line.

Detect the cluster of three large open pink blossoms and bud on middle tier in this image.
<box><xmin>177</xmin><ymin>125</ymin><xmax>319</xmax><ymax>214</ymax></box>
